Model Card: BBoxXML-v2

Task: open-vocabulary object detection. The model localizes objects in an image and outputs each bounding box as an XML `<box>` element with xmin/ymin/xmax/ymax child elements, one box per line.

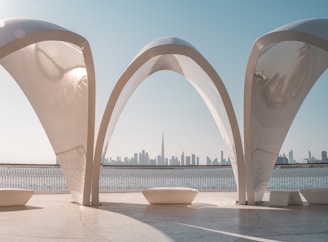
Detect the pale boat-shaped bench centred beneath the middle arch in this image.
<box><xmin>142</xmin><ymin>187</ymin><xmax>198</xmax><ymax>204</ymax></box>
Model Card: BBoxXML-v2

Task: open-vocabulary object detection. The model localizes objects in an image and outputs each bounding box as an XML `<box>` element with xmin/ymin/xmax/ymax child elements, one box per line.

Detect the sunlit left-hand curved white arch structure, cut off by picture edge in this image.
<box><xmin>0</xmin><ymin>19</ymin><xmax>95</xmax><ymax>205</ymax></box>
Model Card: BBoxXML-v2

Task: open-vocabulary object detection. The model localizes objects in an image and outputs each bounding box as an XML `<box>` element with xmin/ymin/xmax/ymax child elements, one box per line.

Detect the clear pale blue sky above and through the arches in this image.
<box><xmin>0</xmin><ymin>0</ymin><xmax>328</xmax><ymax>163</ymax></box>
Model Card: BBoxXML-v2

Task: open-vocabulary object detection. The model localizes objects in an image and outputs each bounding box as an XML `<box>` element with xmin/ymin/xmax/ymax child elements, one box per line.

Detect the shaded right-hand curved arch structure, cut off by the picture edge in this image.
<box><xmin>244</xmin><ymin>19</ymin><xmax>328</xmax><ymax>204</ymax></box>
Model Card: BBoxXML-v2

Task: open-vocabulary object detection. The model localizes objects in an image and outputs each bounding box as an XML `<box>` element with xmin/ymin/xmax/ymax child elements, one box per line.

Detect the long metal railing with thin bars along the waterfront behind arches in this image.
<box><xmin>0</xmin><ymin>164</ymin><xmax>328</xmax><ymax>193</ymax></box>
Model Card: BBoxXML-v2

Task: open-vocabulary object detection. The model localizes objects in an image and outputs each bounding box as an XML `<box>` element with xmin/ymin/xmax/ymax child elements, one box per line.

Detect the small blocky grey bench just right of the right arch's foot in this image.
<box><xmin>269</xmin><ymin>191</ymin><xmax>303</xmax><ymax>207</ymax></box>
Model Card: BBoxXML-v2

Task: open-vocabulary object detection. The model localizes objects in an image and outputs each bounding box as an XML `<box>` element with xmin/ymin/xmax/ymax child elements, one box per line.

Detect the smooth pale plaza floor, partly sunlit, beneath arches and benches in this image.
<box><xmin>0</xmin><ymin>192</ymin><xmax>328</xmax><ymax>242</ymax></box>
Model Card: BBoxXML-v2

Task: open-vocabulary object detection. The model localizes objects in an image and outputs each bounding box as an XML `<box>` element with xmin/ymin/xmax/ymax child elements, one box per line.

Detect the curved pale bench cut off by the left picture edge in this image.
<box><xmin>0</xmin><ymin>188</ymin><xmax>34</xmax><ymax>207</ymax></box>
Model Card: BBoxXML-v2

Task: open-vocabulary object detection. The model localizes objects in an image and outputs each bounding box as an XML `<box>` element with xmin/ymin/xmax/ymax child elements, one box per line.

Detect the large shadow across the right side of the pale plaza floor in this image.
<box><xmin>86</xmin><ymin>199</ymin><xmax>328</xmax><ymax>242</ymax></box>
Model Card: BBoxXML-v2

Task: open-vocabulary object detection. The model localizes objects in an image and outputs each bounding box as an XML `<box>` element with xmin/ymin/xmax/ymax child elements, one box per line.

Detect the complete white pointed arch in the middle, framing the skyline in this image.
<box><xmin>92</xmin><ymin>37</ymin><xmax>246</xmax><ymax>204</ymax></box>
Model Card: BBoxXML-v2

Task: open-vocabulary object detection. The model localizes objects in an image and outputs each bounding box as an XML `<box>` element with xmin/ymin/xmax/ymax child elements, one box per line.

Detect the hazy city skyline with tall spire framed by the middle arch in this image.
<box><xmin>104</xmin><ymin>135</ymin><xmax>230</xmax><ymax>166</ymax></box>
